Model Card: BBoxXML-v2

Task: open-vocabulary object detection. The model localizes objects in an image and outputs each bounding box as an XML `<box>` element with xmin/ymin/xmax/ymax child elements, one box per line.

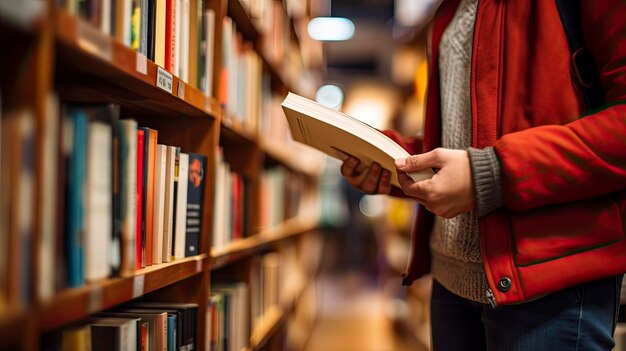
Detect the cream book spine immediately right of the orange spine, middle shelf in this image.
<box><xmin>152</xmin><ymin>144</ymin><xmax>167</xmax><ymax>264</ymax></box>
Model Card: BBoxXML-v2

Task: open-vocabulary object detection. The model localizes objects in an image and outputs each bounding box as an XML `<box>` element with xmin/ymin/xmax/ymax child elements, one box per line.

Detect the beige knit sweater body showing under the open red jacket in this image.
<box><xmin>430</xmin><ymin>0</ymin><xmax>490</xmax><ymax>303</ymax></box>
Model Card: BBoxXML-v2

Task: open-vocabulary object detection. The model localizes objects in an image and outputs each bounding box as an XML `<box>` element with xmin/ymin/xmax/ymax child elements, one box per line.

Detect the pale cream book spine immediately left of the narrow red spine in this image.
<box><xmin>118</xmin><ymin>119</ymin><xmax>137</xmax><ymax>277</ymax></box>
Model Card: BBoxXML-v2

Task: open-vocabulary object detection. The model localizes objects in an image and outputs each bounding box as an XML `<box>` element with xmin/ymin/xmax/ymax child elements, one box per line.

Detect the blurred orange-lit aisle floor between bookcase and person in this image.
<box><xmin>305</xmin><ymin>273</ymin><xmax>425</xmax><ymax>351</ymax></box>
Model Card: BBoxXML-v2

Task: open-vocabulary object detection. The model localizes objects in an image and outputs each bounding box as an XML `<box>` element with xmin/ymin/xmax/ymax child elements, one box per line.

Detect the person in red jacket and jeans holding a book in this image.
<box><xmin>341</xmin><ymin>0</ymin><xmax>626</xmax><ymax>351</ymax></box>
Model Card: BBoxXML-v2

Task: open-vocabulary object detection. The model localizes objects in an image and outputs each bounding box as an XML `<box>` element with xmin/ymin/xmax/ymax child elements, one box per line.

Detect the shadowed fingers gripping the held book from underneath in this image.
<box><xmin>341</xmin><ymin>157</ymin><xmax>391</xmax><ymax>195</ymax></box>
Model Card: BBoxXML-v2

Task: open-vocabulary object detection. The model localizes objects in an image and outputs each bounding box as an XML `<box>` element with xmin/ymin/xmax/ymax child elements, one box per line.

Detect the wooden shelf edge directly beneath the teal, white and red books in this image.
<box><xmin>39</xmin><ymin>254</ymin><xmax>206</xmax><ymax>331</ymax></box>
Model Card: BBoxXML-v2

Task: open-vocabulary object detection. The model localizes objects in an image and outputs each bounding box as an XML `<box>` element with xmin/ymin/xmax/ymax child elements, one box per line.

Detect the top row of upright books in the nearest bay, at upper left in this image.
<box><xmin>57</xmin><ymin>0</ymin><xmax>215</xmax><ymax>96</ymax></box>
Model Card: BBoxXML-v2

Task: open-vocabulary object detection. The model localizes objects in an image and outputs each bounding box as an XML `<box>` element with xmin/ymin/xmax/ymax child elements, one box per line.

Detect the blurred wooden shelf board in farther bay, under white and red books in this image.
<box><xmin>210</xmin><ymin>201</ymin><xmax>319</xmax><ymax>270</ymax></box>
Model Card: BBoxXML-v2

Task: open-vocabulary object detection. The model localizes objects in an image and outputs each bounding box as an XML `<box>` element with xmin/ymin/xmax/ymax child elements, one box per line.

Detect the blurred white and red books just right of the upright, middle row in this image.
<box><xmin>211</xmin><ymin>148</ymin><xmax>250</xmax><ymax>253</ymax></box>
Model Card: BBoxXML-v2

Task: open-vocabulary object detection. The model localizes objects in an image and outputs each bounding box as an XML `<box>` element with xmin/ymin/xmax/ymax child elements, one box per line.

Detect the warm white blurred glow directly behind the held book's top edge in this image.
<box><xmin>344</xmin><ymin>83</ymin><xmax>399</xmax><ymax>129</ymax></box>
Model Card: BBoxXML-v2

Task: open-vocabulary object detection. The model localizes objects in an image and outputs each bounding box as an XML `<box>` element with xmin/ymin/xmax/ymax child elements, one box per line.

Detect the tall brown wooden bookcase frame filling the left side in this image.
<box><xmin>0</xmin><ymin>0</ymin><xmax>323</xmax><ymax>350</ymax></box>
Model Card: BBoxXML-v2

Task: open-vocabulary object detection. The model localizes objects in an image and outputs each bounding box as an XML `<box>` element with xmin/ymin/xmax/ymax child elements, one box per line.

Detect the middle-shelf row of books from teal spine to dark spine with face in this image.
<box><xmin>57</xmin><ymin>105</ymin><xmax>206</xmax><ymax>287</ymax></box>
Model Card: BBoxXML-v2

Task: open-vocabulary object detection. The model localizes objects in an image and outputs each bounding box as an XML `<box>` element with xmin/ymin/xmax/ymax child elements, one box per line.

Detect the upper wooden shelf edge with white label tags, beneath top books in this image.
<box><xmin>54</xmin><ymin>9</ymin><xmax>221</xmax><ymax>119</ymax></box>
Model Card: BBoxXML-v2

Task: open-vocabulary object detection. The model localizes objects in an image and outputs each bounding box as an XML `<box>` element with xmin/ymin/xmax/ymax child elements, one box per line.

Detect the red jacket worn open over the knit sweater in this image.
<box><xmin>390</xmin><ymin>0</ymin><xmax>626</xmax><ymax>304</ymax></box>
